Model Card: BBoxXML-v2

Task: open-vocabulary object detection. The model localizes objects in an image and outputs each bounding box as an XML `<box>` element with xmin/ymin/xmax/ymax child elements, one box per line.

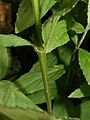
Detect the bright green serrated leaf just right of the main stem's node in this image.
<box><xmin>42</xmin><ymin>18</ymin><xmax>69</xmax><ymax>53</ymax></box>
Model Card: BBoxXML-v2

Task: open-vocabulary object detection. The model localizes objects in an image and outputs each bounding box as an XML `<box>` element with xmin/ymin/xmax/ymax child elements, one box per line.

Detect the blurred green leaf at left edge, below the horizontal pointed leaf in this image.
<box><xmin>0</xmin><ymin>47</ymin><xmax>11</xmax><ymax>79</ymax></box>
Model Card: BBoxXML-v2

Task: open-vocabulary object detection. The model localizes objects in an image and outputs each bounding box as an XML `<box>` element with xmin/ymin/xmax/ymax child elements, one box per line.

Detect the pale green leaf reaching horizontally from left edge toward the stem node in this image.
<box><xmin>0</xmin><ymin>34</ymin><xmax>32</xmax><ymax>47</ymax></box>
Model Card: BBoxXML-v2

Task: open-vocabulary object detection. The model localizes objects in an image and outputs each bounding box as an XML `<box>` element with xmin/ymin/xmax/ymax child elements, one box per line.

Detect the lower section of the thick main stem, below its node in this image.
<box><xmin>38</xmin><ymin>51</ymin><xmax>52</xmax><ymax>114</ymax></box>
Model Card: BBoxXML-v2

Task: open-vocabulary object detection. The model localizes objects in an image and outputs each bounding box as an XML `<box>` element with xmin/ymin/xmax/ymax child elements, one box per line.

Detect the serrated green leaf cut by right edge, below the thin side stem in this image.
<box><xmin>79</xmin><ymin>49</ymin><xmax>90</xmax><ymax>84</ymax></box>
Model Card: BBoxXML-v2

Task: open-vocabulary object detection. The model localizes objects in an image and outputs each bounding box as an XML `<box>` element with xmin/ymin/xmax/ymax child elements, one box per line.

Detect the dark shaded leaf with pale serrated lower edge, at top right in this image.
<box><xmin>53</xmin><ymin>0</ymin><xmax>79</xmax><ymax>17</ymax></box>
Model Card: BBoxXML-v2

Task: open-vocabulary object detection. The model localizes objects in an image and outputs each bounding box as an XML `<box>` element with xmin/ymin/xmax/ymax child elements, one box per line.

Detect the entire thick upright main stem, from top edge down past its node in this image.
<box><xmin>32</xmin><ymin>0</ymin><xmax>52</xmax><ymax>114</ymax></box>
